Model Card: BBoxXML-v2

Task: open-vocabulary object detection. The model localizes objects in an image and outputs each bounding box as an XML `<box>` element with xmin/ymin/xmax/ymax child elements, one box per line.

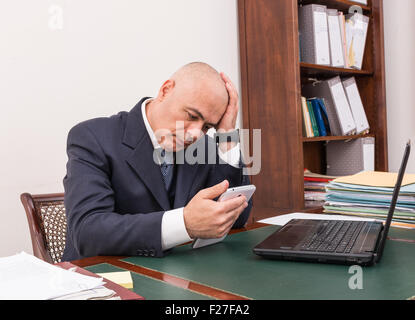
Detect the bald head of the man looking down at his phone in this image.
<box><xmin>146</xmin><ymin>62</ymin><xmax>230</xmax><ymax>150</ymax></box>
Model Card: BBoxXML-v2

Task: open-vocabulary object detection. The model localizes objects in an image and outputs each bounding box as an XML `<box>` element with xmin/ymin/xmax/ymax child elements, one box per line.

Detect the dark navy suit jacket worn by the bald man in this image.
<box><xmin>62</xmin><ymin>98</ymin><xmax>252</xmax><ymax>261</ymax></box>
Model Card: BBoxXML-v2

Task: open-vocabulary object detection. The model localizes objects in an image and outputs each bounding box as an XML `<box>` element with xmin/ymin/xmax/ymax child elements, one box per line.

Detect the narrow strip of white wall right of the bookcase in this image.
<box><xmin>383</xmin><ymin>0</ymin><xmax>415</xmax><ymax>173</ymax></box>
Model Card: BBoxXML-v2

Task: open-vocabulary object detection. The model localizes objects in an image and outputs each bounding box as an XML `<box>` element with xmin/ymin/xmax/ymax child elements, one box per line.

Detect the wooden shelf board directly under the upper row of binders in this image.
<box><xmin>300</xmin><ymin>62</ymin><xmax>373</xmax><ymax>78</ymax></box>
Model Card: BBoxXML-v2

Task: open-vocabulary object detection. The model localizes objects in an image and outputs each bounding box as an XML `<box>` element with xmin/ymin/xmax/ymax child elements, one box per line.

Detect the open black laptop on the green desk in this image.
<box><xmin>253</xmin><ymin>141</ymin><xmax>411</xmax><ymax>266</ymax></box>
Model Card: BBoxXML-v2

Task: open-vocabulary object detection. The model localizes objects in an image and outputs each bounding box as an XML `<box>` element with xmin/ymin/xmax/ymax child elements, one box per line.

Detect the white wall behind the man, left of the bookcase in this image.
<box><xmin>0</xmin><ymin>0</ymin><xmax>240</xmax><ymax>256</ymax></box>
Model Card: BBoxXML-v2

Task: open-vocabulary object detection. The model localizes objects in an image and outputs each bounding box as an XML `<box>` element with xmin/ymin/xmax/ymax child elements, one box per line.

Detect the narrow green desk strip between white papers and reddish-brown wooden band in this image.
<box><xmin>84</xmin><ymin>263</ymin><xmax>211</xmax><ymax>300</ymax></box>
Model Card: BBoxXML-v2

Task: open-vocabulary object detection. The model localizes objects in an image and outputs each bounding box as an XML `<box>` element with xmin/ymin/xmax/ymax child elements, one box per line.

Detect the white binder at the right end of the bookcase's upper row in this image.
<box><xmin>346</xmin><ymin>12</ymin><xmax>369</xmax><ymax>70</ymax></box>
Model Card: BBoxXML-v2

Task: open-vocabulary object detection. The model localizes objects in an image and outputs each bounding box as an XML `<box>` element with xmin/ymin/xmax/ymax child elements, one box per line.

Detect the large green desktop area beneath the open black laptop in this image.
<box><xmin>123</xmin><ymin>226</ymin><xmax>415</xmax><ymax>300</ymax></box>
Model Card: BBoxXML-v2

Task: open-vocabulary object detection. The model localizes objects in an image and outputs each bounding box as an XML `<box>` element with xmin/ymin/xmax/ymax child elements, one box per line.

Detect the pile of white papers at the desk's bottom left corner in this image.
<box><xmin>0</xmin><ymin>252</ymin><xmax>105</xmax><ymax>300</ymax></box>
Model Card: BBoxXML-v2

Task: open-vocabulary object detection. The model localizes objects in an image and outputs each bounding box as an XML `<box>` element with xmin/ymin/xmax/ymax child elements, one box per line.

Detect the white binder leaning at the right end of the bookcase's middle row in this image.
<box><xmin>343</xmin><ymin>77</ymin><xmax>370</xmax><ymax>134</ymax></box>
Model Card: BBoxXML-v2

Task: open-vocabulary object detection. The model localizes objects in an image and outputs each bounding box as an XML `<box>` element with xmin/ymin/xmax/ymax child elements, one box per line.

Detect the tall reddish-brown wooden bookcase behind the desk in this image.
<box><xmin>238</xmin><ymin>0</ymin><xmax>388</xmax><ymax>222</ymax></box>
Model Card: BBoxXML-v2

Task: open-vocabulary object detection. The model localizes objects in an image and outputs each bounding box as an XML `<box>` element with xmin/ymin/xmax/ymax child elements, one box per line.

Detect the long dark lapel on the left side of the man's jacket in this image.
<box><xmin>123</xmin><ymin>98</ymin><xmax>171</xmax><ymax>211</ymax></box>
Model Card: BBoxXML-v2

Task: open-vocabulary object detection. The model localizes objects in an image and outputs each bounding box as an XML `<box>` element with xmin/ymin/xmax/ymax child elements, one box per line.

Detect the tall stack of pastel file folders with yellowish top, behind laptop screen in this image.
<box><xmin>324</xmin><ymin>171</ymin><xmax>415</xmax><ymax>228</ymax></box>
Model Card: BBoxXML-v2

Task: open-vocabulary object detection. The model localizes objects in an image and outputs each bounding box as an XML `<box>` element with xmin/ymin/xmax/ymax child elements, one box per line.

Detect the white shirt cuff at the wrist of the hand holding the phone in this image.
<box><xmin>161</xmin><ymin>208</ymin><xmax>193</xmax><ymax>251</ymax></box>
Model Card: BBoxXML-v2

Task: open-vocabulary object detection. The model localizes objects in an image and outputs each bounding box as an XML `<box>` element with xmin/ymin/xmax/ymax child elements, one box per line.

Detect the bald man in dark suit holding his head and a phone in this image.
<box><xmin>62</xmin><ymin>62</ymin><xmax>252</xmax><ymax>261</ymax></box>
